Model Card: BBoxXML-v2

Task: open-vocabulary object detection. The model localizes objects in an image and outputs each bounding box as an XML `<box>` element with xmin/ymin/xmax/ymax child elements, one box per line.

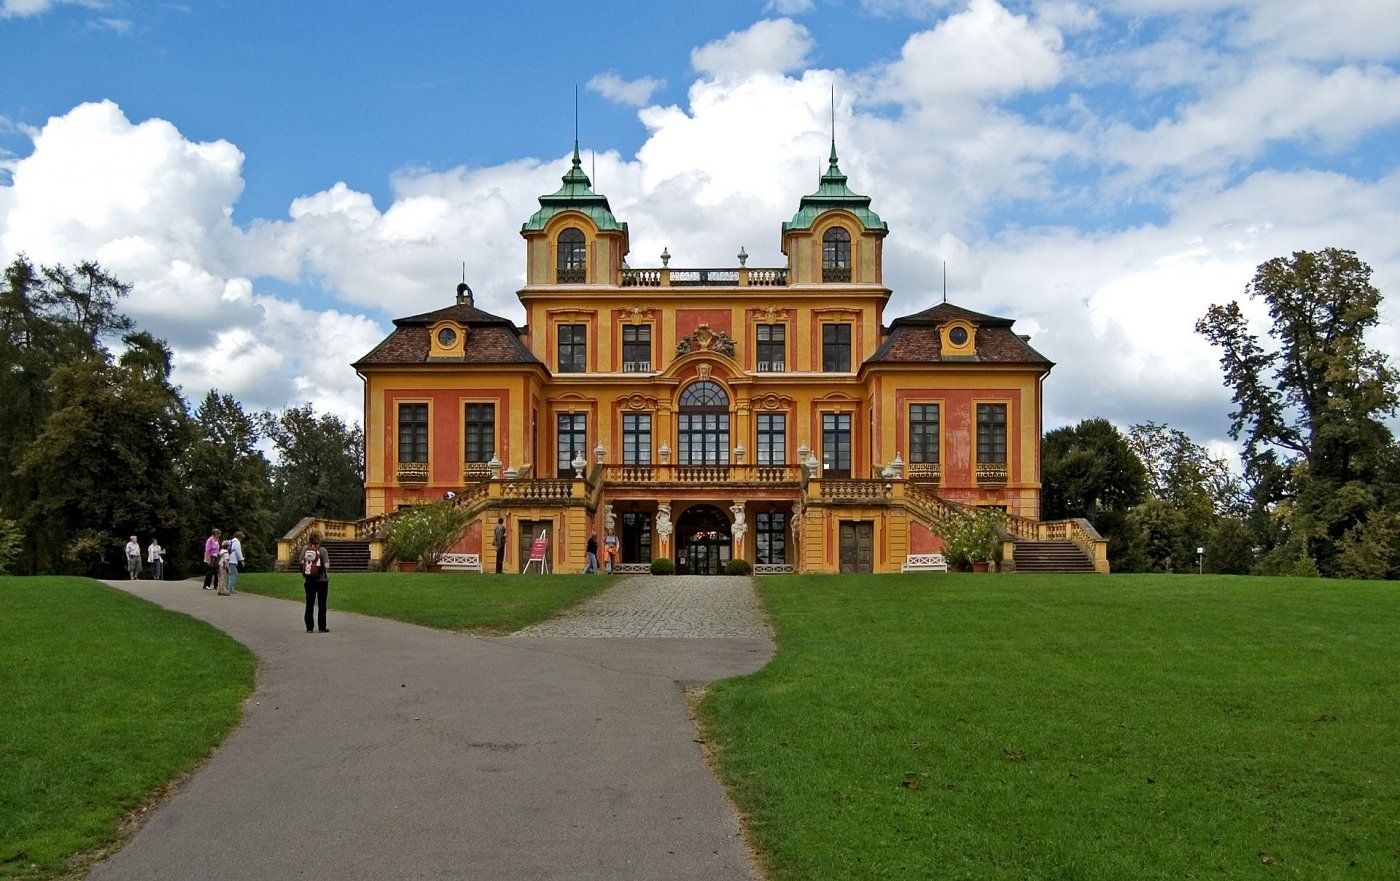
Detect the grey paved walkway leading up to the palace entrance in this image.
<box><xmin>88</xmin><ymin>577</ymin><xmax>773</xmax><ymax>881</ymax></box>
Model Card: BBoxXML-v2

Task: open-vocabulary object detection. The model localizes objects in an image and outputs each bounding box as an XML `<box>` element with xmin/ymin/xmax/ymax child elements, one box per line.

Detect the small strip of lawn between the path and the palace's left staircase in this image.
<box><xmin>237</xmin><ymin>571</ymin><xmax>616</xmax><ymax>634</ymax></box>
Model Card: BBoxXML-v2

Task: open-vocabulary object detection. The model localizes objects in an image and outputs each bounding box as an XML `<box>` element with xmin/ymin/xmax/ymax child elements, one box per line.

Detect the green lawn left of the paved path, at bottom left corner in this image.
<box><xmin>0</xmin><ymin>577</ymin><xmax>255</xmax><ymax>878</ymax></box>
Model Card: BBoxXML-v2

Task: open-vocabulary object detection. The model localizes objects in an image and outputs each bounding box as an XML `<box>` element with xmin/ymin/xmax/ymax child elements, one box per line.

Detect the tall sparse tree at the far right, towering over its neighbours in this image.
<box><xmin>1196</xmin><ymin>248</ymin><xmax>1400</xmax><ymax>576</ymax></box>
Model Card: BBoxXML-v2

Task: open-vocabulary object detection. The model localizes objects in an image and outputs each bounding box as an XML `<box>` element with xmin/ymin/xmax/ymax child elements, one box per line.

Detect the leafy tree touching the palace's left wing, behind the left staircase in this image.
<box><xmin>262</xmin><ymin>403</ymin><xmax>364</xmax><ymax>538</ymax></box>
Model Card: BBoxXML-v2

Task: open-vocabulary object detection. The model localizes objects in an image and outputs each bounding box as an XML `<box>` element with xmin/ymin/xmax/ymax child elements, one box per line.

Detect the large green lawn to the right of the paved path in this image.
<box><xmin>700</xmin><ymin>574</ymin><xmax>1400</xmax><ymax>881</ymax></box>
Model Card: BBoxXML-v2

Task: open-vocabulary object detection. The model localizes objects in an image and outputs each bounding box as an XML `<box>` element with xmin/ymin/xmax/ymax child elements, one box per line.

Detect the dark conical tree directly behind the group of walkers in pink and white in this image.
<box><xmin>182</xmin><ymin>389</ymin><xmax>279</xmax><ymax>570</ymax></box>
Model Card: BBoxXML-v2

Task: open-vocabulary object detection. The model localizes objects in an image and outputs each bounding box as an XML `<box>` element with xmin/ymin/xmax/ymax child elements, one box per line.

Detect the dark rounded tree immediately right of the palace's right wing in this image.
<box><xmin>1040</xmin><ymin>419</ymin><xmax>1148</xmax><ymax>571</ymax></box>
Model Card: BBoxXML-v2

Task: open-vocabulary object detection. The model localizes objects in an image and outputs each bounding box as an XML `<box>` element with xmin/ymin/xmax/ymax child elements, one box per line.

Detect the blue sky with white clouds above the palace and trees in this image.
<box><xmin>0</xmin><ymin>0</ymin><xmax>1400</xmax><ymax>451</ymax></box>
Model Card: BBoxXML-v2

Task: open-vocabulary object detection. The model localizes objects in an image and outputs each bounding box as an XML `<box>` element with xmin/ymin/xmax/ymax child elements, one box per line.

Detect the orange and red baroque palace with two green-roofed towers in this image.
<box><xmin>280</xmin><ymin>143</ymin><xmax>1106</xmax><ymax>574</ymax></box>
